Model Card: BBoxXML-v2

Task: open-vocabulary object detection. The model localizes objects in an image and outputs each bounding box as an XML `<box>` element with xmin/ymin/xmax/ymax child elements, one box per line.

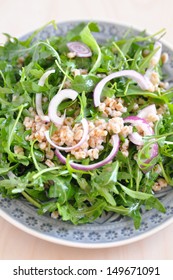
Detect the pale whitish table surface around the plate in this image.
<box><xmin>0</xmin><ymin>0</ymin><xmax>173</xmax><ymax>260</ymax></box>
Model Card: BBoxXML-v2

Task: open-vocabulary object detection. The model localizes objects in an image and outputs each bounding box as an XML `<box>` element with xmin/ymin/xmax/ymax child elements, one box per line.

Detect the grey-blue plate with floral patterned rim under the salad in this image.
<box><xmin>0</xmin><ymin>21</ymin><xmax>173</xmax><ymax>248</ymax></box>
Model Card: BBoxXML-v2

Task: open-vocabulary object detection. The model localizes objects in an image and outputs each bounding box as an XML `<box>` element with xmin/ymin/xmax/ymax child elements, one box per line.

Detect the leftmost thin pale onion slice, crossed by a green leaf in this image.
<box><xmin>35</xmin><ymin>69</ymin><xmax>55</xmax><ymax>122</ymax></box>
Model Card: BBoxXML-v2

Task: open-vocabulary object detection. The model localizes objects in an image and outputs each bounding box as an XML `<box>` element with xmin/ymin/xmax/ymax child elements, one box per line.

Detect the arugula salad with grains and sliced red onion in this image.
<box><xmin>0</xmin><ymin>22</ymin><xmax>173</xmax><ymax>228</ymax></box>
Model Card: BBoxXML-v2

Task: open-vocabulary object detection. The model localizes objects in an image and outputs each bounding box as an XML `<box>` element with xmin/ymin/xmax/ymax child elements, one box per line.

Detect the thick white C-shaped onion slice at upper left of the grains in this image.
<box><xmin>48</xmin><ymin>89</ymin><xmax>78</xmax><ymax>126</ymax></box>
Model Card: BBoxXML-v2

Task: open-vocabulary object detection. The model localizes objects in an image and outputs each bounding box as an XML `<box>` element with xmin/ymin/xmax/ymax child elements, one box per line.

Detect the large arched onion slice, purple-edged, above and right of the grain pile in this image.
<box><xmin>93</xmin><ymin>70</ymin><xmax>153</xmax><ymax>107</ymax></box>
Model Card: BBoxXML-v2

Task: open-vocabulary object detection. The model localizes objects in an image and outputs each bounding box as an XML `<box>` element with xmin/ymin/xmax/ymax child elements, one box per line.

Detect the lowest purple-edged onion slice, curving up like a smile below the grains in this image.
<box><xmin>55</xmin><ymin>134</ymin><xmax>120</xmax><ymax>171</ymax></box>
